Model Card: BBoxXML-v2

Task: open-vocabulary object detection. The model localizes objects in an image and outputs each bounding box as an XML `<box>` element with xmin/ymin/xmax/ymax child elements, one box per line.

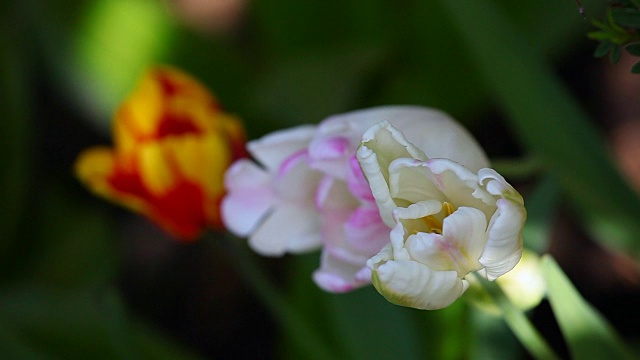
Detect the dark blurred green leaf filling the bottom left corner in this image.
<box><xmin>0</xmin><ymin>285</ymin><xmax>196</xmax><ymax>359</ymax></box>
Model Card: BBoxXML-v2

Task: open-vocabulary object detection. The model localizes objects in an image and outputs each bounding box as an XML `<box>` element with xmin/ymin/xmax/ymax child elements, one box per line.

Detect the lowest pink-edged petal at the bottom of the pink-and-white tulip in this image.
<box><xmin>313</xmin><ymin>251</ymin><xmax>371</xmax><ymax>293</ymax></box>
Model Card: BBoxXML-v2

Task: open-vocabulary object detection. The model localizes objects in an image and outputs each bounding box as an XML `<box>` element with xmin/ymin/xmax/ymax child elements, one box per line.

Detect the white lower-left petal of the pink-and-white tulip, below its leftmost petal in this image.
<box><xmin>249</xmin><ymin>204</ymin><xmax>322</xmax><ymax>256</ymax></box>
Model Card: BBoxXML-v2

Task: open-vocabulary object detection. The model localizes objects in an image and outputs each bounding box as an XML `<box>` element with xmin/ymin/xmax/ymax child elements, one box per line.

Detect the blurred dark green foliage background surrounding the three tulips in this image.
<box><xmin>0</xmin><ymin>0</ymin><xmax>640</xmax><ymax>359</ymax></box>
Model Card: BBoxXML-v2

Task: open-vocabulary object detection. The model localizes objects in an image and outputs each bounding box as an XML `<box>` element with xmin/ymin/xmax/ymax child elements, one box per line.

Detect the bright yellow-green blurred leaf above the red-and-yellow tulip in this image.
<box><xmin>72</xmin><ymin>0</ymin><xmax>173</xmax><ymax>131</ymax></box>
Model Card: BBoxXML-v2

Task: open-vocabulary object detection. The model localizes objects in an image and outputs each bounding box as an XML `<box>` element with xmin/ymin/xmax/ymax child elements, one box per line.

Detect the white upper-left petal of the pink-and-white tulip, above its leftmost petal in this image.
<box><xmin>247</xmin><ymin>125</ymin><xmax>316</xmax><ymax>172</ymax></box>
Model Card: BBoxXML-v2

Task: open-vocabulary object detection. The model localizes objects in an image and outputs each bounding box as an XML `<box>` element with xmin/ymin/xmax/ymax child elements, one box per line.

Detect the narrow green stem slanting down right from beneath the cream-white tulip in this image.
<box><xmin>475</xmin><ymin>274</ymin><xmax>559</xmax><ymax>360</ymax></box>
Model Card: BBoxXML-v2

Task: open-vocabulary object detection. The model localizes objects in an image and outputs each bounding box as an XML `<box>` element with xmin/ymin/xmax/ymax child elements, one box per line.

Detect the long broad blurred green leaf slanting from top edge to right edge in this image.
<box><xmin>441</xmin><ymin>0</ymin><xmax>640</xmax><ymax>256</ymax></box>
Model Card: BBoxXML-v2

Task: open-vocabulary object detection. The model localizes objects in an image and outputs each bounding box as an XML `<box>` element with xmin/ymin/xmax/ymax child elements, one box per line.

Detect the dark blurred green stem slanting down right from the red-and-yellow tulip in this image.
<box><xmin>208</xmin><ymin>236</ymin><xmax>336</xmax><ymax>360</ymax></box>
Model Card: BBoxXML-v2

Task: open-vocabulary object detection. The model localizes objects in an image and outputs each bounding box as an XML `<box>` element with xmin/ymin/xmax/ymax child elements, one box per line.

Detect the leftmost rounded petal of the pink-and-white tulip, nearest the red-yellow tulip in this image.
<box><xmin>221</xmin><ymin>160</ymin><xmax>275</xmax><ymax>237</ymax></box>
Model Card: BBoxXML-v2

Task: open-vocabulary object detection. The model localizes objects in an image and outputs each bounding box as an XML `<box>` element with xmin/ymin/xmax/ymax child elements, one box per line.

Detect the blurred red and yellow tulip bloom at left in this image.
<box><xmin>75</xmin><ymin>67</ymin><xmax>245</xmax><ymax>241</ymax></box>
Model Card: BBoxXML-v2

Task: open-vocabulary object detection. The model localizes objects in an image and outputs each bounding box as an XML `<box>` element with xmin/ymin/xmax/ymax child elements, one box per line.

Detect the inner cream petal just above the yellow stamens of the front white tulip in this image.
<box><xmin>389</xmin><ymin>158</ymin><xmax>447</xmax><ymax>207</ymax></box>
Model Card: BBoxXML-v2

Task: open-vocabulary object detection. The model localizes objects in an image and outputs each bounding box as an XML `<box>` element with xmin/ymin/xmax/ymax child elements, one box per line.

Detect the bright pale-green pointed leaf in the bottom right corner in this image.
<box><xmin>542</xmin><ymin>255</ymin><xmax>632</xmax><ymax>359</ymax></box>
